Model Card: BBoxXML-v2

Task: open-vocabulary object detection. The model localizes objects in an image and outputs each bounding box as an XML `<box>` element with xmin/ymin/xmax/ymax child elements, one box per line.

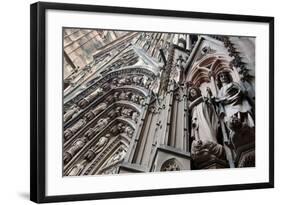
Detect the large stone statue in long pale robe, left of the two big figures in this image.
<box><xmin>189</xmin><ymin>87</ymin><xmax>224</xmax><ymax>162</ymax></box>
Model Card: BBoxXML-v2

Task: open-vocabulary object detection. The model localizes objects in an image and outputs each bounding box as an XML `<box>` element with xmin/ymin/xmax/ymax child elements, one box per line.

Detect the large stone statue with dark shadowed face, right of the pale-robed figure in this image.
<box><xmin>216</xmin><ymin>71</ymin><xmax>255</xmax><ymax>137</ymax></box>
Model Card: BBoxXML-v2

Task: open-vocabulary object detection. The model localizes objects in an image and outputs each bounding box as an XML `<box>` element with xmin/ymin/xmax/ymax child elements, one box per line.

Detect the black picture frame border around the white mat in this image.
<box><xmin>30</xmin><ymin>2</ymin><xmax>274</xmax><ymax>203</ymax></box>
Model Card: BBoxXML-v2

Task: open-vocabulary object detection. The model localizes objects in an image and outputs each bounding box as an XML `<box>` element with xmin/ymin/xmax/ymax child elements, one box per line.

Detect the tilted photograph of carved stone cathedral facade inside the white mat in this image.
<box><xmin>62</xmin><ymin>28</ymin><xmax>255</xmax><ymax>176</ymax></box>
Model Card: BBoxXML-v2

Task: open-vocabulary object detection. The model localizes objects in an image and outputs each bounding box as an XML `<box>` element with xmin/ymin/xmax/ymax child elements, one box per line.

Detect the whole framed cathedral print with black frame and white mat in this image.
<box><xmin>30</xmin><ymin>2</ymin><xmax>274</xmax><ymax>203</ymax></box>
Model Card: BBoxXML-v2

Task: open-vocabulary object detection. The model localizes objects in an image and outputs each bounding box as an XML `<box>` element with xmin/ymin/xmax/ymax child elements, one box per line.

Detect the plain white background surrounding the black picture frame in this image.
<box><xmin>0</xmin><ymin>0</ymin><xmax>276</xmax><ymax>205</ymax></box>
